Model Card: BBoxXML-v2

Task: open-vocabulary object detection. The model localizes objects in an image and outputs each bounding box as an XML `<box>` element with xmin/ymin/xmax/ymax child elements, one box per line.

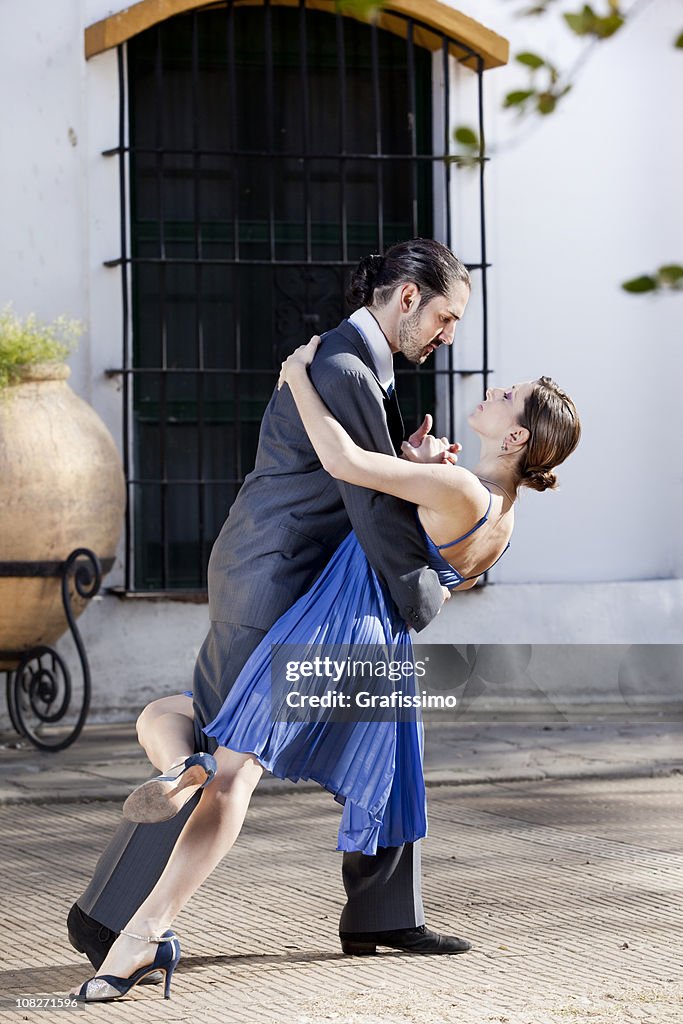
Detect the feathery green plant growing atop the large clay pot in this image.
<box><xmin>0</xmin><ymin>303</ymin><xmax>83</xmax><ymax>389</ymax></box>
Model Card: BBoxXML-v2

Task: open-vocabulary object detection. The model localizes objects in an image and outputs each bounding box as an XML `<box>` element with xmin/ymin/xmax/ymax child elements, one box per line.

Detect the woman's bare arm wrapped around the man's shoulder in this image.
<box><xmin>279</xmin><ymin>339</ymin><xmax>481</xmax><ymax>514</ymax></box>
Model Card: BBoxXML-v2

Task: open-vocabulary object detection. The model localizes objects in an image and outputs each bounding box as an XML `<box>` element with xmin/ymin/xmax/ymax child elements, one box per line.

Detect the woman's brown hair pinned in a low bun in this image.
<box><xmin>519</xmin><ymin>377</ymin><xmax>581</xmax><ymax>490</ymax></box>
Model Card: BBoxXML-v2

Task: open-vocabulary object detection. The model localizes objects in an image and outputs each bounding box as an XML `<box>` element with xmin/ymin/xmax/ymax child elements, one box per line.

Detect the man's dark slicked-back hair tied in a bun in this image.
<box><xmin>346</xmin><ymin>239</ymin><xmax>472</xmax><ymax>311</ymax></box>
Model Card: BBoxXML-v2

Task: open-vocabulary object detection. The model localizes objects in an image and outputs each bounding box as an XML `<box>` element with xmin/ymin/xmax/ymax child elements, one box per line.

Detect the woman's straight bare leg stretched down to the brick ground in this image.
<box><xmin>78</xmin><ymin>745</ymin><xmax>263</xmax><ymax>978</ymax></box>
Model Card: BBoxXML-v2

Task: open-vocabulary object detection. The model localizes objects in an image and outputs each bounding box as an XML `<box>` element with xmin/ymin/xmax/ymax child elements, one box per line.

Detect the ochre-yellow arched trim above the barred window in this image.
<box><xmin>85</xmin><ymin>0</ymin><xmax>510</xmax><ymax>68</ymax></box>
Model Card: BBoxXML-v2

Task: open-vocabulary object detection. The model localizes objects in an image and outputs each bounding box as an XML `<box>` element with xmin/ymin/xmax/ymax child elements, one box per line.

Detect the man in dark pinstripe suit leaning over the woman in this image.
<box><xmin>68</xmin><ymin>239</ymin><xmax>470</xmax><ymax>968</ymax></box>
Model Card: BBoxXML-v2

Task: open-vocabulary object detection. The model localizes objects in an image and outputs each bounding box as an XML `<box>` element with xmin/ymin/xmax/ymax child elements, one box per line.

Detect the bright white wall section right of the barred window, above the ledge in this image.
<box><xmin>453</xmin><ymin>0</ymin><xmax>683</xmax><ymax>583</ymax></box>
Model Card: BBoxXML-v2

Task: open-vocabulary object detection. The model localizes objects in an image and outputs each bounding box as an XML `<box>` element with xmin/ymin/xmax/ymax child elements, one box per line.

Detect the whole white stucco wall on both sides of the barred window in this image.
<box><xmin>0</xmin><ymin>0</ymin><xmax>683</xmax><ymax>718</ymax></box>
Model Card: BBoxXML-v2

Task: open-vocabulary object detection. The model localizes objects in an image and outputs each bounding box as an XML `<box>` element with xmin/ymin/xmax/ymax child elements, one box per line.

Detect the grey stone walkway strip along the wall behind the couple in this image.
<box><xmin>0</xmin><ymin>719</ymin><xmax>683</xmax><ymax>805</ymax></box>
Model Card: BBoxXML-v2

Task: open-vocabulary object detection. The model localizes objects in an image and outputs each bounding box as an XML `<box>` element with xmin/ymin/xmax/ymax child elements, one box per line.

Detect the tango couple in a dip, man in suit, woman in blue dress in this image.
<box><xmin>68</xmin><ymin>239</ymin><xmax>580</xmax><ymax>1001</ymax></box>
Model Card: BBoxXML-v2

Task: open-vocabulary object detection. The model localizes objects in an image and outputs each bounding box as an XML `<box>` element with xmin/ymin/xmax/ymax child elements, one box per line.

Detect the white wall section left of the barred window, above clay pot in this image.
<box><xmin>0</xmin><ymin>0</ymin><xmax>123</xmax><ymax>585</ymax></box>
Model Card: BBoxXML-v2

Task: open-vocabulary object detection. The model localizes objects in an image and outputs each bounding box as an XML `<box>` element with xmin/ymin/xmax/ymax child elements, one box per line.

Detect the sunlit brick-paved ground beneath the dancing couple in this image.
<box><xmin>0</xmin><ymin>774</ymin><xmax>683</xmax><ymax>1024</ymax></box>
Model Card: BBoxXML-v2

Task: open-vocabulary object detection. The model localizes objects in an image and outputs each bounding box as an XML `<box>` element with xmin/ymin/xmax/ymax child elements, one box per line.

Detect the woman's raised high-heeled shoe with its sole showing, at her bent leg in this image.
<box><xmin>123</xmin><ymin>752</ymin><xmax>218</xmax><ymax>824</ymax></box>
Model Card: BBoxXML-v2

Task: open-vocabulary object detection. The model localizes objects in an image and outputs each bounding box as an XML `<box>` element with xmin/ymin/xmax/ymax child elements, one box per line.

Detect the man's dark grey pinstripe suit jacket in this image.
<box><xmin>209</xmin><ymin>321</ymin><xmax>443</xmax><ymax>630</ymax></box>
